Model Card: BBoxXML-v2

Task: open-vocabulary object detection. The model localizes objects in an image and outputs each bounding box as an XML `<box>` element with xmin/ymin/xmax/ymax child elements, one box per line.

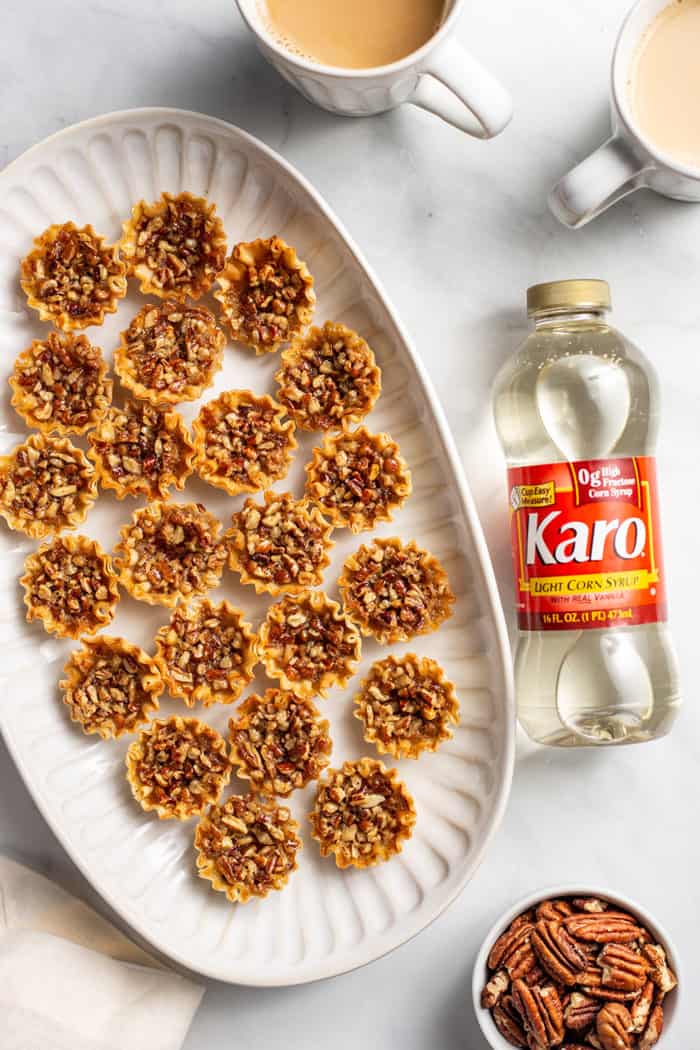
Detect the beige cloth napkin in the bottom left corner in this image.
<box><xmin>0</xmin><ymin>857</ymin><xmax>204</xmax><ymax>1050</ymax></box>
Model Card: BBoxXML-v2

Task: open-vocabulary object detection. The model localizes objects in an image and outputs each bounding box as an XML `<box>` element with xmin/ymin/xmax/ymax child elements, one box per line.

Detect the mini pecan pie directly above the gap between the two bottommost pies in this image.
<box><xmin>229</xmin><ymin>689</ymin><xmax>333</xmax><ymax>796</ymax></box>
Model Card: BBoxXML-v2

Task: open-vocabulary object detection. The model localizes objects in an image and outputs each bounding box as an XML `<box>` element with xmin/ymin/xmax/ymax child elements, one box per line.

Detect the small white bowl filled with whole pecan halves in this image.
<box><xmin>472</xmin><ymin>886</ymin><xmax>679</xmax><ymax>1050</ymax></box>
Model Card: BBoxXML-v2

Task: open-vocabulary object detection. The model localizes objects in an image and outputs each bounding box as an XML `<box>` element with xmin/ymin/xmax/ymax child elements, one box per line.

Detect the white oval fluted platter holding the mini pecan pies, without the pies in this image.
<box><xmin>0</xmin><ymin>109</ymin><xmax>514</xmax><ymax>985</ymax></box>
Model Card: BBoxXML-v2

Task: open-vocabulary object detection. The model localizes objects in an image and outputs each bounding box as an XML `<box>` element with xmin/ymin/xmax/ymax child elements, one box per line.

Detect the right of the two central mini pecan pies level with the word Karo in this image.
<box><xmin>228</xmin><ymin>490</ymin><xmax>333</xmax><ymax>594</ymax></box>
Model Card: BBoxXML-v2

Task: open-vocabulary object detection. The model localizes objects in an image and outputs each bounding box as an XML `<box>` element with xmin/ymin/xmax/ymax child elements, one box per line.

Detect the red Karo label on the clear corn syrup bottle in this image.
<box><xmin>508</xmin><ymin>457</ymin><xmax>666</xmax><ymax>631</ymax></box>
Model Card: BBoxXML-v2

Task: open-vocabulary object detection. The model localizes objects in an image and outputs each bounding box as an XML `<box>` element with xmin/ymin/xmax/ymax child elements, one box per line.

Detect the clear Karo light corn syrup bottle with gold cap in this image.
<box><xmin>494</xmin><ymin>280</ymin><xmax>681</xmax><ymax>747</ymax></box>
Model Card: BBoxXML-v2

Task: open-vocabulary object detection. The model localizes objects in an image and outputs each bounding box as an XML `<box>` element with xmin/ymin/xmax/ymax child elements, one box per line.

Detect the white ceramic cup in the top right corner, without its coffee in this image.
<box><xmin>549</xmin><ymin>0</ymin><xmax>700</xmax><ymax>228</ymax></box>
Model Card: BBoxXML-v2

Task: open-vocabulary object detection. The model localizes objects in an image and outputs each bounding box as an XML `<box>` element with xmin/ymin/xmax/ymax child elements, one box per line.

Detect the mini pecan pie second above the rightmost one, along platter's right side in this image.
<box><xmin>306</xmin><ymin>426</ymin><xmax>410</xmax><ymax>532</ymax></box>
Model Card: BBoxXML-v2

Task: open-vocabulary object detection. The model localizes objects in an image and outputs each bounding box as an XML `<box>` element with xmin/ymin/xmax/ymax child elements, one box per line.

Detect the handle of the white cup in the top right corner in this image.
<box><xmin>549</xmin><ymin>134</ymin><xmax>650</xmax><ymax>229</ymax></box>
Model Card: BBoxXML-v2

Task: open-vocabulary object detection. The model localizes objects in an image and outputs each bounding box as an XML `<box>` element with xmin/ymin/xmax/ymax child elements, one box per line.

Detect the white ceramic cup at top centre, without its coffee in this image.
<box><xmin>236</xmin><ymin>0</ymin><xmax>512</xmax><ymax>139</ymax></box>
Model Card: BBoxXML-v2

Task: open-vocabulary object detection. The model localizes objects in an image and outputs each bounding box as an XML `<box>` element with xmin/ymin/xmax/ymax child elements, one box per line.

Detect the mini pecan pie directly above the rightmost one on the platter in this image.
<box><xmin>338</xmin><ymin>537</ymin><xmax>454</xmax><ymax>645</ymax></box>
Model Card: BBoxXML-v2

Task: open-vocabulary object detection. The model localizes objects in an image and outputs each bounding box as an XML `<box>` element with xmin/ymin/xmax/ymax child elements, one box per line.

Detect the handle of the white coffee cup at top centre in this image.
<box><xmin>409</xmin><ymin>40</ymin><xmax>513</xmax><ymax>139</ymax></box>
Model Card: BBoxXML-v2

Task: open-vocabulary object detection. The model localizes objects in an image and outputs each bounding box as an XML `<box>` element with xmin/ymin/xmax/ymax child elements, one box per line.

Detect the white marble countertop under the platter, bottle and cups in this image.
<box><xmin>0</xmin><ymin>0</ymin><xmax>700</xmax><ymax>1050</ymax></box>
